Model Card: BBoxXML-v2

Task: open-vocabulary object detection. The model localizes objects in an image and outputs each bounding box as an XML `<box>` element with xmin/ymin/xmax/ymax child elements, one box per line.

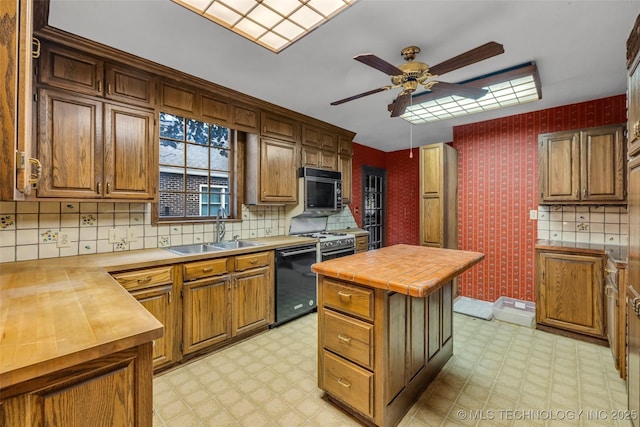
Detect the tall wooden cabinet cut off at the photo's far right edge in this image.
<box><xmin>627</xmin><ymin>16</ymin><xmax>640</xmax><ymax>427</ymax></box>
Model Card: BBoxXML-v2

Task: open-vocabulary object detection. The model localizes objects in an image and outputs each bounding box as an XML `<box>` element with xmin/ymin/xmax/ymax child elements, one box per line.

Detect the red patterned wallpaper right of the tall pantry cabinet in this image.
<box><xmin>453</xmin><ymin>95</ymin><xmax>626</xmax><ymax>301</ymax></box>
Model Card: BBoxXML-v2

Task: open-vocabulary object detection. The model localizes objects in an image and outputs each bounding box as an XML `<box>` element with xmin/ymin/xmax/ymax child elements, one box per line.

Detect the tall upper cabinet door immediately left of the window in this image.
<box><xmin>104</xmin><ymin>104</ymin><xmax>158</xmax><ymax>199</ymax></box>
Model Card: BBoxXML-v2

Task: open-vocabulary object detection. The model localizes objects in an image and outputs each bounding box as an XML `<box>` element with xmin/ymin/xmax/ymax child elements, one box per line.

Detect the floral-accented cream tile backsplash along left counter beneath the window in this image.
<box><xmin>0</xmin><ymin>202</ymin><xmax>357</xmax><ymax>262</ymax></box>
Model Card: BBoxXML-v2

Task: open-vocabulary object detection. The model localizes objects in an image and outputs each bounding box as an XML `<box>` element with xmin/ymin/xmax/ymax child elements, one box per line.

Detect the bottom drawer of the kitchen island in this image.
<box><xmin>322</xmin><ymin>350</ymin><xmax>374</xmax><ymax>417</ymax></box>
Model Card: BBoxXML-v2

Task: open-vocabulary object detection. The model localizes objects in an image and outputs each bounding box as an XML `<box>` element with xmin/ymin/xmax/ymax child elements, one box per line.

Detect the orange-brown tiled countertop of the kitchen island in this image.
<box><xmin>311</xmin><ymin>245</ymin><xmax>484</xmax><ymax>298</ymax></box>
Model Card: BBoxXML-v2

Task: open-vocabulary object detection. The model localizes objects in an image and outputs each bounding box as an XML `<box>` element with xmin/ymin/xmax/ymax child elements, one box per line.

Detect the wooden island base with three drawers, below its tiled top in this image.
<box><xmin>318</xmin><ymin>275</ymin><xmax>453</xmax><ymax>426</ymax></box>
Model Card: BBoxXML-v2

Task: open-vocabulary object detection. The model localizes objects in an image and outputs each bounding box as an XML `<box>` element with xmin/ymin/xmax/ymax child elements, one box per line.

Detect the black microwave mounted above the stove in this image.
<box><xmin>299</xmin><ymin>167</ymin><xmax>342</xmax><ymax>215</ymax></box>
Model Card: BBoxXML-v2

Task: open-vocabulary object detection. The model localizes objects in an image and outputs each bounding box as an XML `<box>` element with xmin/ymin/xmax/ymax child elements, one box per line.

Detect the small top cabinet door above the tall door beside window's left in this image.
<box><xmin>104</xmin><ymin>64</ymin><xmax>157</xmax><ymax>108</ymax></box>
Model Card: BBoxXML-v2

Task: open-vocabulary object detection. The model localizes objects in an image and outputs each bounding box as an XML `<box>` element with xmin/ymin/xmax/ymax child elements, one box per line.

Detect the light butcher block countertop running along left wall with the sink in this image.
<box><xmin>0</xmin><ymin>236</ymin><xmax>316</xmax><ymax>389</ymax></box>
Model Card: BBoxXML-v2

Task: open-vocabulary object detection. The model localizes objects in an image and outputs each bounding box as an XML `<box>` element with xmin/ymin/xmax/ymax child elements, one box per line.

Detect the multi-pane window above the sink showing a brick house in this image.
<box><xmin>157</xmin><ymin>113</ymin><xmax>234</xmax><ymax>222</ymax></box>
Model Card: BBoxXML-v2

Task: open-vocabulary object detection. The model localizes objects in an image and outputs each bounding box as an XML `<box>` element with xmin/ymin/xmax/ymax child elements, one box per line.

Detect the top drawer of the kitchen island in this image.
<box><xmin>322</xmin><ymin>277</ymin><xmax>373</xmax><ymax>321</ymax></box>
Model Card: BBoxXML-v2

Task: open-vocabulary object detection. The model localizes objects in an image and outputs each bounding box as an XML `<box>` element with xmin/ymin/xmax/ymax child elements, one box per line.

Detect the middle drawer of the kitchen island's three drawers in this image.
<box><xmin>323</xmin><ymin>310</ymin><xmax>374</xmax><ymax>369</ymax></box>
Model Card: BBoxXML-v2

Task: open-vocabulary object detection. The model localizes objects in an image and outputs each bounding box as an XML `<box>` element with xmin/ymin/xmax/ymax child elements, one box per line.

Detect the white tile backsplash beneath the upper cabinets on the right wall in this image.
<box><xmin>538</xmin><ymin>205</ymin><xmax>629</xmax><ymax>245</ymax></box>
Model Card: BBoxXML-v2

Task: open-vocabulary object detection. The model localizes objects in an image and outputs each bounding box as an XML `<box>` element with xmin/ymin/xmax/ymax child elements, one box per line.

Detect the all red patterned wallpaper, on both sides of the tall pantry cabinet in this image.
<box><xmin>350</xmin><ymin>95</ymin><xmax>626</xmax><ymax>301</ymax></box>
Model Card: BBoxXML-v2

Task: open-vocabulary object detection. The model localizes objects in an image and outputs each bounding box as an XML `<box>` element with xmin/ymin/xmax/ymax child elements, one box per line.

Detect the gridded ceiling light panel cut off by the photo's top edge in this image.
<box><xmin>172</xmin><ymin>0</ymin><xmax>357</xmax><ymax>53</ymax></box>
